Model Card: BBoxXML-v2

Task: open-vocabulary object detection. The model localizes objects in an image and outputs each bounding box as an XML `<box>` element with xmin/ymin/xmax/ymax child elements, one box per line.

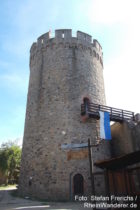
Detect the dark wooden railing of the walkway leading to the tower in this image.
<box><xmin>81</xmin><ymin>102</ymin><xmax>134</xmax><ymax>122</ymax></box>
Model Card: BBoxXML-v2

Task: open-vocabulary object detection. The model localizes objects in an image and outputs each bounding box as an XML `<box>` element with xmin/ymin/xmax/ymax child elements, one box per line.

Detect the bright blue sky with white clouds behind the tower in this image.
<box><xmin>0</xmin><ymin>0</ymin><xmax>140</xmax><ymax>144</ymax></box>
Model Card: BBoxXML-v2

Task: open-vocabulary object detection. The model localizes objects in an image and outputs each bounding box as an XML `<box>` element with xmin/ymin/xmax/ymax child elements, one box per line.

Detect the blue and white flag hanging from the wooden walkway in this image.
<box><xmin>99</xmin><ymin>111</ymin><xmax>111</xmax><ymax>140</ymax></box>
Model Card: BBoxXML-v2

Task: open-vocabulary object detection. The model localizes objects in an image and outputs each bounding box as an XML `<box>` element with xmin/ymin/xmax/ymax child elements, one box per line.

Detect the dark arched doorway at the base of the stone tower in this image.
<box><xmin>73</xmin><ymin>174</ymin><xmax>84</xmax><ymax>195</ymax></box>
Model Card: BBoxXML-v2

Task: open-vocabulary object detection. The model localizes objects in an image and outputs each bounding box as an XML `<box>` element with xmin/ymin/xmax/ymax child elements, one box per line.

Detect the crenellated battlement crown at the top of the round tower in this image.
<box><xmin>30</xmin><ymin>29</ymin><xmax>103</xmax><ymax>65</ymax></box>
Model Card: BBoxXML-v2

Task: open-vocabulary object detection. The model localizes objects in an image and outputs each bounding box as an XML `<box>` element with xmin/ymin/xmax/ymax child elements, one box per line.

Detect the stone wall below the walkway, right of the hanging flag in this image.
<box><xmin>111</xmin><ymin>121</ymin><xmax>140</xmax><ymax>156</ymax></box>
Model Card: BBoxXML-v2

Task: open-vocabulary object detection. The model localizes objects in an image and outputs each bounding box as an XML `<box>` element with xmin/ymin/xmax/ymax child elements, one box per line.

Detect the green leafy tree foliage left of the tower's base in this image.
<box><xmin>0</xmin><ymin>142</ymin><xmax>21</xmax><ymax>183</ymax></box>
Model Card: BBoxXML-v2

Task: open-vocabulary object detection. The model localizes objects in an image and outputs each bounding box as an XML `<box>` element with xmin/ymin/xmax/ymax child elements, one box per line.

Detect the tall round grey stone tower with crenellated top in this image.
<box><xmin>19</xmin><ymin>29</ymin><xmax>109</xmax><ymax>200</ymax></box>
